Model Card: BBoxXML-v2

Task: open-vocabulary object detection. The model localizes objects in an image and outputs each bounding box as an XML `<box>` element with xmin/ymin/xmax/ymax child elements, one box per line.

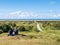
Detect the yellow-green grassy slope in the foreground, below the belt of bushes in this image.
<box><xmin>0</xmin><ymin>30</ymin><xmax>60</xmax><ymax>45</ymax></box>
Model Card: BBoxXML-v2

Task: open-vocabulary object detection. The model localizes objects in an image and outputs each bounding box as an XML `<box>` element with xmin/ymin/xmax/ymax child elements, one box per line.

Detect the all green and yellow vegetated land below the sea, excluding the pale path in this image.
<box><xmin>0</xmin><ymin>21</ymin><xmax>60</xmax><ymax>45</ymax></box>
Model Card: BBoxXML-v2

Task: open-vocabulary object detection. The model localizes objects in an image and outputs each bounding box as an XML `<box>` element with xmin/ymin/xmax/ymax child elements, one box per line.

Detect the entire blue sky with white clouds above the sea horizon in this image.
<box><xmin>0</xmin><ymin>0</ymin><xmax>60</xmax><ymax>19</ymax></box>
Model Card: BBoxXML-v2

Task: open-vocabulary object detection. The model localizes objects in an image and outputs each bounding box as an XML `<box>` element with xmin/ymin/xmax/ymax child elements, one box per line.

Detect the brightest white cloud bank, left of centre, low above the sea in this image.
<box><xmin>7</xmin><ymin>11</ymin><xmax>41</xmax><ymax>19</ymax></box>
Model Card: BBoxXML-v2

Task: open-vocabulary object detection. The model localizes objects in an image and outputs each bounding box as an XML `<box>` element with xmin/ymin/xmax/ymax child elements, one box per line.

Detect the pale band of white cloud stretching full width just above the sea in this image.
<box><xmin>0</xmin><ymin>10</ymin><xmax>60</xmax><ymax>19</ymax></box>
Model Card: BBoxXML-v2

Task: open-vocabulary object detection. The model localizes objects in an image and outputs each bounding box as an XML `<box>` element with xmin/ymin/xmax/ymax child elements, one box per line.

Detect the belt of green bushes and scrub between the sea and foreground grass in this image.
<box><xmin>0</xmin><ymin>21</ymin><xmax>60</xmax><ymax>32</ymax></box>
